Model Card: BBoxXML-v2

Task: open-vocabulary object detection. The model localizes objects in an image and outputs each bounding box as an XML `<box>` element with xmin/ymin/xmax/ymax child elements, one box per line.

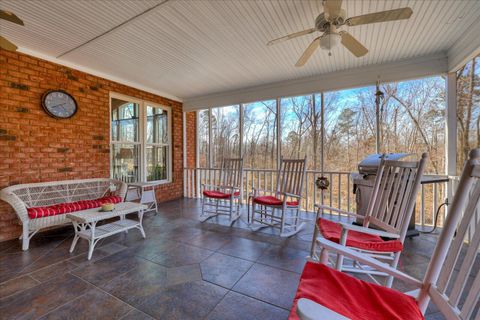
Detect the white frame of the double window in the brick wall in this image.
<box><xmin>109</xmin><ymin>92</ymin><xmax>173</xmax><ymax>184</ymax></box>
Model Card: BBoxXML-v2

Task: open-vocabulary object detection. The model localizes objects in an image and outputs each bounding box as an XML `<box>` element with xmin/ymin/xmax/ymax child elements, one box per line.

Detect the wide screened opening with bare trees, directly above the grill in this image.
<box><xmin>380</xmin><ymin>77</ymin><xmax>446</xmax><ymax>174</ymax></box>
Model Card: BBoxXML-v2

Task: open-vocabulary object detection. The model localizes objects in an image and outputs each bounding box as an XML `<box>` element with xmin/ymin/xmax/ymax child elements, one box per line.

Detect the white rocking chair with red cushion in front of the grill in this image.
<box><xmin>310</xmin><ymin>153</ymin><xmax>427</xmax><ymax>287</ymax></box>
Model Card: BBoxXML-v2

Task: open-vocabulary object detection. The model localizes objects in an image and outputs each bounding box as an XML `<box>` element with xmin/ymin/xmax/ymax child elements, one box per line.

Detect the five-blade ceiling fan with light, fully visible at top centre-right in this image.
<box><xmin>267</xmin><ymin>0</ymin><xmax>413</xmax><ymax>67</ymax></box>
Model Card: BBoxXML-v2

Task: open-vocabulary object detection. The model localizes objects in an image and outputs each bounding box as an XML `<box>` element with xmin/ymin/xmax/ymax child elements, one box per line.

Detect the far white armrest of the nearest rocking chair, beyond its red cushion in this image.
<box><xmin>315</xmin><ymin>237</ymin><xmax>423</xmax><ymax>288</ymax></box>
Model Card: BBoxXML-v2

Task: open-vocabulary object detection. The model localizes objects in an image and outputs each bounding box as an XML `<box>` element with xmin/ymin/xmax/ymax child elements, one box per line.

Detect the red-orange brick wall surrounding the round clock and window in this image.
<box><xmin>0</xmin><ymin>49</ymin><xmax>183</xmax><ymax>241</ymax></box>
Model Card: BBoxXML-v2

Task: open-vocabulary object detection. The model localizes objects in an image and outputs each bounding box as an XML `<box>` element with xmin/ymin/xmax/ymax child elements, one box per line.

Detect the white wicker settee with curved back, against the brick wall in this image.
<box><xmin>0</xmin><ymin>178</ymin><xmax>127</xmax><ymax>250</ymax></box>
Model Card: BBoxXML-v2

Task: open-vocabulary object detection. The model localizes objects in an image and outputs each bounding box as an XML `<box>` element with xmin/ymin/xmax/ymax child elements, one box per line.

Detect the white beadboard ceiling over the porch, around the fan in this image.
<box><xmin>0</xmin><ymin>0</ymin><xmax>480</xmax><ymax>105</ymax></box>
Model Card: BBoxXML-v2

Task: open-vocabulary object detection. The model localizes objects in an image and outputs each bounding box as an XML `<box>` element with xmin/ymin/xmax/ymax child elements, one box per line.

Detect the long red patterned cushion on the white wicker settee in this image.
<box><xmin>27</xmin><ymin>196</ymin><xmax>122</xmax><ymax>219</ymax></box>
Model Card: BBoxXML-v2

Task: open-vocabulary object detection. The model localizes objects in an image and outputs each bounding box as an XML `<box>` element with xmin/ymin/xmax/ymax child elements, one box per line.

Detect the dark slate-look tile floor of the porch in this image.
<box><xmin>0</xmin><ymin>199</ymin><xmax>456</xmax><ymax>320</ymax></box>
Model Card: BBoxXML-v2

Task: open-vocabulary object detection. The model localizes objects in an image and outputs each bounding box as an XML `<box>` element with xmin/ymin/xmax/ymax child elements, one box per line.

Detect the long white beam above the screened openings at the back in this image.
<box><xmin>183</xmin><ymin>54</ymin><xmax>448</xmax><ymax>111</ymax></box>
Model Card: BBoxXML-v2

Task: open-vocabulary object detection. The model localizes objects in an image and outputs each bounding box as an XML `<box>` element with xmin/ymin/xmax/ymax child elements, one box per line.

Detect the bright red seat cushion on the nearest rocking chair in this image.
<box><xmin>289</xmin><ymin>261</ymin><xmax>424</xmax><ymax>320</ymax></box>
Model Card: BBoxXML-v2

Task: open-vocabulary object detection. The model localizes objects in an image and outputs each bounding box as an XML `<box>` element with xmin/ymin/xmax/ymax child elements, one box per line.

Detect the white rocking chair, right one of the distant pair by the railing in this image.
<box><xmin>248</xmin><ymin>158</ymin><xmax>307</xmax><ymax>237</ymax></box>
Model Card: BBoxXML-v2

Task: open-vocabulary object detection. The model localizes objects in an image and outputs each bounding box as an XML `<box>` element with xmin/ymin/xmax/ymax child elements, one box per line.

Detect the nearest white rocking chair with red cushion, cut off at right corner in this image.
<box><xmin>289</xmin><ymin>149</ymin><xmax>480</xmax><ymax>320</ymax></box>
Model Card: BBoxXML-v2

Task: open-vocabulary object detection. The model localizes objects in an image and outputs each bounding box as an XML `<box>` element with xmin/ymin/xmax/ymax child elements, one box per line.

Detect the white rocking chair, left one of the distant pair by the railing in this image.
<box><xmin>200</xmin><ymin>158</ymin><xmax>243</xmax><ymax>225</ymax></box>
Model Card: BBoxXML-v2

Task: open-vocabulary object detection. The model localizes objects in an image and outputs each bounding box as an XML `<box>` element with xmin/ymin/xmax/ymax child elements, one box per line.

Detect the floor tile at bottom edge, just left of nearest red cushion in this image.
<box><xmin>207</xmin><ymin>291</ymin><xmax>289</xmax><ymax>320</ymax></box>
